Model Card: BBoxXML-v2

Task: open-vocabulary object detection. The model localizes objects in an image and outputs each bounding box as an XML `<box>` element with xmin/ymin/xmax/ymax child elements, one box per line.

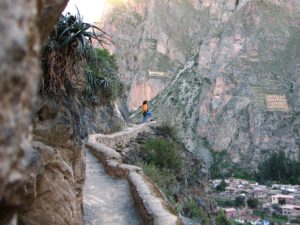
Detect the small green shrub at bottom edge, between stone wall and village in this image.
<box><xmin>181</xmin><ymin>199</ymin><xmax>209</xmax><ymax>224</ymax></box>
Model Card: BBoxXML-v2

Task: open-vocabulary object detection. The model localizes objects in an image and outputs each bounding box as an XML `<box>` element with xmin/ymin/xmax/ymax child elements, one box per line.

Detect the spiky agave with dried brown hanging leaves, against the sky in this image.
<box><xmin>41</xmin><ymin>9</ymin><xmax>109</xmax><ymax>95</ymax></box>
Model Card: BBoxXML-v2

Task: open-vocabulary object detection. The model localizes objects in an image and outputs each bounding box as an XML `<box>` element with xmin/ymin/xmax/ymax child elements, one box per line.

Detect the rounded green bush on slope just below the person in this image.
<box><xmin>141</xmin><ymin>138</ymin><xmax>182</xmax><ymax>171</ymax></box>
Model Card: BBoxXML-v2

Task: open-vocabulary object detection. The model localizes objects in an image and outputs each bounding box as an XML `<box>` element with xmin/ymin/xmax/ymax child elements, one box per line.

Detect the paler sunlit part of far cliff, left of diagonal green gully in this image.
<box><xmin>100</xmin><ymin>0</ymin><xmax>208</xmax><ymax>110</ymax></box>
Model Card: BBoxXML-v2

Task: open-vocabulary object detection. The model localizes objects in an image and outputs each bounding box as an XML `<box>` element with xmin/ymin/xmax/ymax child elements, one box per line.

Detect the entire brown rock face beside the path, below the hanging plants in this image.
<box><xmin>19</xmin><ymin>98</ymin><xmax>85</xmax><ymax>225</ymax></box>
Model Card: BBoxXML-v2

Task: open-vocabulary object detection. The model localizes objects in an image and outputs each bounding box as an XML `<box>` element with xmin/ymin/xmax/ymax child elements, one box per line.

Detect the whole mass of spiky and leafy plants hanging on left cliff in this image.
<box><xmin>41</xmin><ymin>12</ymin><xmax>122</xmax><ymax>104</ymax></box>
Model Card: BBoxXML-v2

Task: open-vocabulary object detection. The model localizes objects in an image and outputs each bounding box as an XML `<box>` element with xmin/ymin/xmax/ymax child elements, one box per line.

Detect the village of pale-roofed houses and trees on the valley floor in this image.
<box><xmin>211</xmin><ymin>178</ymin><xmax>300</xmax><ymax>225</ymax></box>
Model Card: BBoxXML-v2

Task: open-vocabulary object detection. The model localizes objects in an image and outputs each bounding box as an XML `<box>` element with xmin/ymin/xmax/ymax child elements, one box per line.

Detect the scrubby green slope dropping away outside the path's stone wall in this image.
<box><xmin>126</xmin><ymin>124</ymin><xmax>216</xmax><ymax>224</ymax></box>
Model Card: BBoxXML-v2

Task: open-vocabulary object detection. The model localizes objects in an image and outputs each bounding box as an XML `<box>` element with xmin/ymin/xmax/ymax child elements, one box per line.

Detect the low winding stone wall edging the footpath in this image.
<box><xmin>87</xmin><ymin>132</ymin><xmax>183</xmax><ymax>225</ymax></box>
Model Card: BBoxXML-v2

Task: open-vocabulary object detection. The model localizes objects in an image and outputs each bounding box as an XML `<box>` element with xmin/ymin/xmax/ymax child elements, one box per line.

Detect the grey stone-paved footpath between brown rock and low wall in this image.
<box><xmin>83</xmin><ymin>150</ymin><xmax>143</xmax><ymax>225</ymax></box>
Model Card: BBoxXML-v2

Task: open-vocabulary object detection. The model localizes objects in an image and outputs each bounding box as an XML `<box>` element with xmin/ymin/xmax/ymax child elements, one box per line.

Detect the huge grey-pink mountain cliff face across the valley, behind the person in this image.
<box><xmin>104</xmin><ymin>0</ymin><xmax>300</xmax><ymax>167</ymax></box>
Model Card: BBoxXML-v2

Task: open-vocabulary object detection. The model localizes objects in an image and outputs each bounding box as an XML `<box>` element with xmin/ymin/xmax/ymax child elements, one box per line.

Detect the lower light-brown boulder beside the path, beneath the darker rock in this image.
<box><xmin>19</xmin><ymin>142</ymin><xmax>85</xmax><ymax>225</ymax></box>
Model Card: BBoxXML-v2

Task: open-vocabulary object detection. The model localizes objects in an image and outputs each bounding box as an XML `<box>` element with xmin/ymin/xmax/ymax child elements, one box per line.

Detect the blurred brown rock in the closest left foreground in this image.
<box><xmin>0</xmin><ymin>0</ymin><xmax>67</xmax><ymax>224</ymax></box>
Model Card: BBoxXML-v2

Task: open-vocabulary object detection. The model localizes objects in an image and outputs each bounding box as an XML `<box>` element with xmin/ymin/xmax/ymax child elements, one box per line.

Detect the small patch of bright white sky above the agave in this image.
<box><xmin>63</xmin><ymin>0</ymin><xmax>106</xmax><ymax>23</ymax></box>
